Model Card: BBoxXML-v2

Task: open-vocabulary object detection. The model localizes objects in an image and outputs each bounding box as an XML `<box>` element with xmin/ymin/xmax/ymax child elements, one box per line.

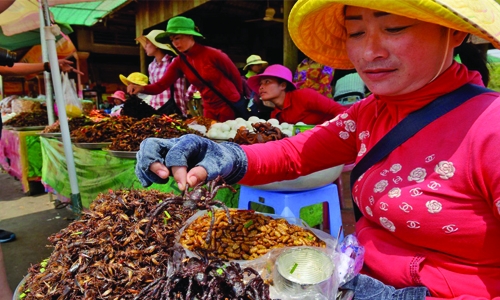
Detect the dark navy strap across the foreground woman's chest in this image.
<box><xmin>350</xmin><ymin>84</ymin><xmax>491</xmax><ymax>220</ymax></box>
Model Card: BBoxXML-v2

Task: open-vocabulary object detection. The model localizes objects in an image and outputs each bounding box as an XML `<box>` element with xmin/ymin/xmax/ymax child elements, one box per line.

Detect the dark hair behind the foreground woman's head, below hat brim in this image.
<box><xmin>453</xmin><ymin>36</ymin><xmax>490</xmax><ymax>86</ymax></box>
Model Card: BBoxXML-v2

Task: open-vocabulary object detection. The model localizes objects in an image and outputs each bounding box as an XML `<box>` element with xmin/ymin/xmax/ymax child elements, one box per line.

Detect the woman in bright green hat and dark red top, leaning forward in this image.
<box><xmin>127</xmin><ymin>17</ymin><xmax>243</xmax><ymax>122</ymax></box>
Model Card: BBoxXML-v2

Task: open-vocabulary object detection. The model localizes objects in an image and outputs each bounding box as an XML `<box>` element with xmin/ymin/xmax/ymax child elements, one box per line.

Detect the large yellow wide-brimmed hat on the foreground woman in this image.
<box><xmin>288</xmin><ymin>0</ymin><xmax>500</xmax><ymax>69</ymax></box>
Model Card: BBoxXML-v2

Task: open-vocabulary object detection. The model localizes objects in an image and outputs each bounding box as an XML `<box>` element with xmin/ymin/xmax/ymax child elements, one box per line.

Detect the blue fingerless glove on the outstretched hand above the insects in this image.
<box><xmin>135</xmin><ymin>134</ymin><xmax>248</xmax><ymax>187</ymax></box>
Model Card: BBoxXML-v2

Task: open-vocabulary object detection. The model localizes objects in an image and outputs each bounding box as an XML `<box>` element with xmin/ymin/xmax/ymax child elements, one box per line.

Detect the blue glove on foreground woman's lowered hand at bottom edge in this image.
<box><xmin>340</xmin><ymin>274</ymin><xmax>427</xmax><ymax>300</ymax></box>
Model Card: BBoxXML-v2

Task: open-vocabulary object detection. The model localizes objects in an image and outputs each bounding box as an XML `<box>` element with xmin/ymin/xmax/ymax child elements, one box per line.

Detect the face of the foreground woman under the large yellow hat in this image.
<box><xmin>345</xmin><ymin>6</ymin><xmax>466</xmax><ymax>96</ymax></box>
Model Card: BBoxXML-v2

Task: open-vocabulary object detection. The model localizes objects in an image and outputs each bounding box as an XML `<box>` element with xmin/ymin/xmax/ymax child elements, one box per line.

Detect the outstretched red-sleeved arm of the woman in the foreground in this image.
<box><xmin>240</xmin><ymin>105</ymin><xmax>357</xmax><ymax>185</ymax></box>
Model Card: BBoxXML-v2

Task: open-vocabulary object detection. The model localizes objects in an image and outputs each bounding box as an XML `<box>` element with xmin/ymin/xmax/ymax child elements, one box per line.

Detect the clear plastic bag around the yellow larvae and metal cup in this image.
<box><xmin>176</xmin><ymin>210</ymin><xmax>339</xmax><ymax>300</ymax></box>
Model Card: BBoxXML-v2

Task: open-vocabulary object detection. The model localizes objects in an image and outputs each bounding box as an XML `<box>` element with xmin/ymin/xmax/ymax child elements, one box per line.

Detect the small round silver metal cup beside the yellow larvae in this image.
<box><xmin>274</xmin><ymin>247</ymin><xmax>335</xmax><ymax>296</ymax></box>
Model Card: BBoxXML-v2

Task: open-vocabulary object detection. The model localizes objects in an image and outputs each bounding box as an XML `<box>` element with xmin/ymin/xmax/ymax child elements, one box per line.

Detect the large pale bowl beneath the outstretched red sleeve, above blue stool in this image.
<box><xmin>246</xmin><ymin>165</ymin><xmax>344</xmax><ymax>192</ymax></box>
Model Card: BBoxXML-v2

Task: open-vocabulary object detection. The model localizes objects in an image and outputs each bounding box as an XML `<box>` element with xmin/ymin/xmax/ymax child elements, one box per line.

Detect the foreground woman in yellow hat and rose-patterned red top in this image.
<box><xmin>136</xmin><ymin>0</ymin><xmax>500</xmax><ymax>300</ymax></box>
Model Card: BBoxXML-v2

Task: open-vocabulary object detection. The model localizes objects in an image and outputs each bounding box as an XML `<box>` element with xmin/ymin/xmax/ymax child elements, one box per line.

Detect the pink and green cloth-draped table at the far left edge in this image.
<box><xmin>0</xmin><ymin>129</ymin><xmax>42</xmax><ymax>194</ymax></box>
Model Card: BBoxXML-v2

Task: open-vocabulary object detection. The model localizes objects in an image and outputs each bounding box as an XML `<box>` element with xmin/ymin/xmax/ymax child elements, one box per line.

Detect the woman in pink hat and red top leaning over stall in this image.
<box><xmin>248</xmin><ymin>65</ymin><xmax>346</xmax><ymax>125</ymax></box>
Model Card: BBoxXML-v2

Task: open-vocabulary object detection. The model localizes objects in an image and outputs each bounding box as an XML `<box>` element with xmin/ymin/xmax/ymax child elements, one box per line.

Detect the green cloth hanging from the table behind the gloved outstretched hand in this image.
<box><xmin>39</xmin><ymin>137</ymin><xmax>239</xmax><ymax>208</ymax></box>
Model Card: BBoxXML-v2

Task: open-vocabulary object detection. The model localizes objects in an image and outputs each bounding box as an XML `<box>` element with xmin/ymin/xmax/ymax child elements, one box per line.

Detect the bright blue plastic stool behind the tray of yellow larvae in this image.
<box><xmin>238</xmin><ymin>184</ymin><xmax>344</xmax><ymax>240</ymax></box>
